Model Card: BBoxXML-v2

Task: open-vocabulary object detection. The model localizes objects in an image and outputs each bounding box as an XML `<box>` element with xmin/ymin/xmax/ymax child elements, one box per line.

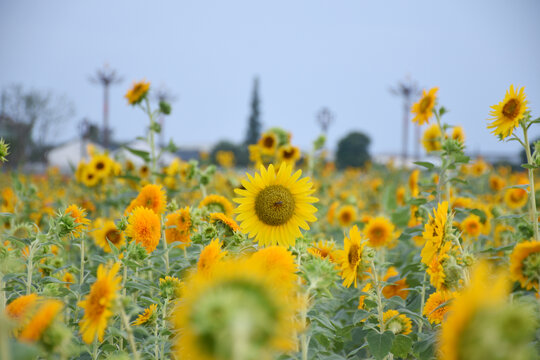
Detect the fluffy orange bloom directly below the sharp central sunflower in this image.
<box><xmin>251</xmin><ymin>246</ymin><xmax>298</xmax><ymax>286</ymax></box>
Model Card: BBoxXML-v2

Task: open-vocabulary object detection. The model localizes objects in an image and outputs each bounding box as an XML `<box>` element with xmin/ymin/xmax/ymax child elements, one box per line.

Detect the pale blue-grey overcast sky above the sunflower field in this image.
<box><xmin>0</xmin><ymin>0</ymin><xmax>540</xmax><ymax>158</ymax></box>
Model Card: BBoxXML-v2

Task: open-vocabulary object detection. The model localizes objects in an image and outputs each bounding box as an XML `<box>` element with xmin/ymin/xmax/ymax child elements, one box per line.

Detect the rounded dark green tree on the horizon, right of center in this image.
<box><xmin>336</xmin><ymin>132</ymin><xmax>371</xmax><ymax>169</ymax></box>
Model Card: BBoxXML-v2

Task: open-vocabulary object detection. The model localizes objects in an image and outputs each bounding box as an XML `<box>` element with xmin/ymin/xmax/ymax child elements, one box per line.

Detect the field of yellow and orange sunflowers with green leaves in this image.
<box><xmin>0</xmin><ymin>81</ymin><xmax>540</xmax><ymax>360</ymax></box>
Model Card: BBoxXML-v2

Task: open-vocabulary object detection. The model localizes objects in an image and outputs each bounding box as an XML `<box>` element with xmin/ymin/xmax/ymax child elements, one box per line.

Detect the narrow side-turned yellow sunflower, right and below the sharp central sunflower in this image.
<box><xmin>336</xmin><ymin>225</ymin><xmax>367</xmax><ymax>287</ymax></box>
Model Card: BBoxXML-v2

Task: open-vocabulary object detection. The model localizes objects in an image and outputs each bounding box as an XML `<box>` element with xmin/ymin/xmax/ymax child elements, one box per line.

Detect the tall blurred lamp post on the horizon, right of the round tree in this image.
<box><xmin>390</xmin><ymin>76</ymin><xmax>420</xmax><ymax>165</ymax></box>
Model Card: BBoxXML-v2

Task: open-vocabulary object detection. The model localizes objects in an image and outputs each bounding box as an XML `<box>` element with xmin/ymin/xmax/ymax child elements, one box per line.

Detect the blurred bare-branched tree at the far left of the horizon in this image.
<box><xmin>0</xmin><ymin>85</ymin><xmax>74</xmax><ymax>167</ymax></box>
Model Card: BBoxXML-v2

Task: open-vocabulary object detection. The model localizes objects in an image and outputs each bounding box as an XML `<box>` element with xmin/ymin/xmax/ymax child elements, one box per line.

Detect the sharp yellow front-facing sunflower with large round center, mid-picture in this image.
<box><xmin>234</xmin><ymin>163</ymin><xmax>319</xmax><ymax>246</ymax></box>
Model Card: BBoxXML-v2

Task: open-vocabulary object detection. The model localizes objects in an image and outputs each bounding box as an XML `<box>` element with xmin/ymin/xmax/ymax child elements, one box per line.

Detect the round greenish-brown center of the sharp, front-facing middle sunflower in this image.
<box><xmin>255</xmin><ymin>185</ymin><xmax>295</xmax><ymax>226</ymax></box>
